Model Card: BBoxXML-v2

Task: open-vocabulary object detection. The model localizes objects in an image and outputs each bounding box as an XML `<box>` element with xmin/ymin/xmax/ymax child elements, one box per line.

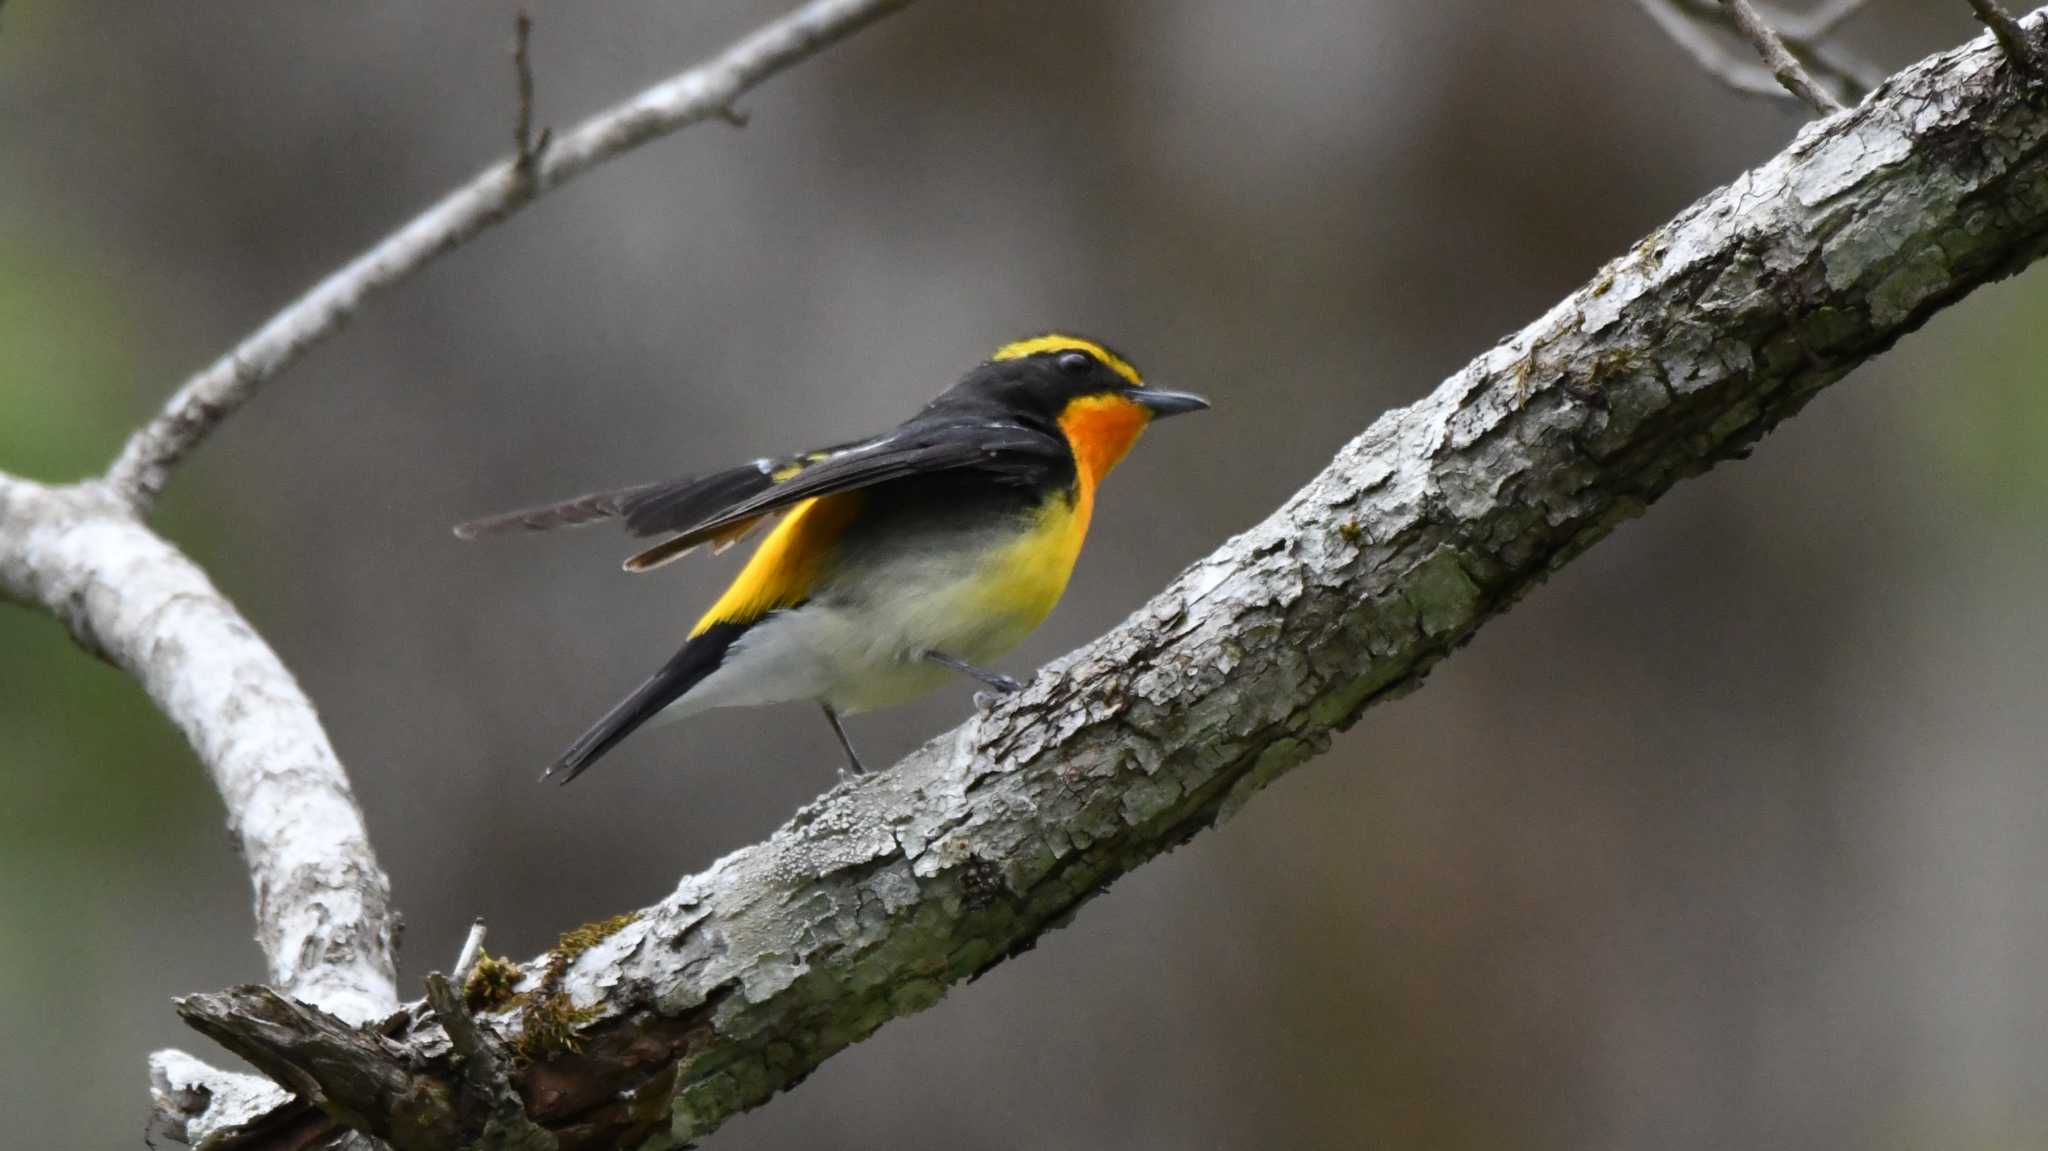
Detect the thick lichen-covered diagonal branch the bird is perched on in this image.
<box><xmin>167</xmin><ymin>12</ymin><xmax>2048</xmax><ymax>1151</ymax></box>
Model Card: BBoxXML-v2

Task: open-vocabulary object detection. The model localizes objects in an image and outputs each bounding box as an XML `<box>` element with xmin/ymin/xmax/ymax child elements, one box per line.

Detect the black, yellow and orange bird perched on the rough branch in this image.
<box><xmin>455</xmin><ymin>334</ymin><xmax>1208</xmax><ymax>782</ymax></box>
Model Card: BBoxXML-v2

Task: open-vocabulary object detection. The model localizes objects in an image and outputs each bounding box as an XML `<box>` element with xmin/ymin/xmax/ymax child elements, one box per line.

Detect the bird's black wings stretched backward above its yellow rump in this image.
<box><xmin>455</xmin><ymin>414</ymin><xmax>1073</xmax><ymax>571</ymax></box>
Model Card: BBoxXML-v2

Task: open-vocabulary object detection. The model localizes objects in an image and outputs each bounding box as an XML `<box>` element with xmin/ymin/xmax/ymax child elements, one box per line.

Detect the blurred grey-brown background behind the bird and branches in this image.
<box><xmin>0</xmin><ymin>0</ymin><xmax>2048</xmax><ymax>1149</ymax></box>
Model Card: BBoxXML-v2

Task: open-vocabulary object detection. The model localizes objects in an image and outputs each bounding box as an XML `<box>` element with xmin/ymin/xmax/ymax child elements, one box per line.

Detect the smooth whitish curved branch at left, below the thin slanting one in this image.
<box><xmin>0</xmin><ymin>475</ymin><xmax>397</xmax><ymax>1022</ymax></box>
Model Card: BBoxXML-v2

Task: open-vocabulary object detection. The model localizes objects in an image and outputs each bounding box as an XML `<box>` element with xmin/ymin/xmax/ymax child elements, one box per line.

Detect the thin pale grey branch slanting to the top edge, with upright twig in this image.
<box><xmin>106</xmin><ymin>0</ymin><xmax>909</xmax><ymax>508</ymax></box>
